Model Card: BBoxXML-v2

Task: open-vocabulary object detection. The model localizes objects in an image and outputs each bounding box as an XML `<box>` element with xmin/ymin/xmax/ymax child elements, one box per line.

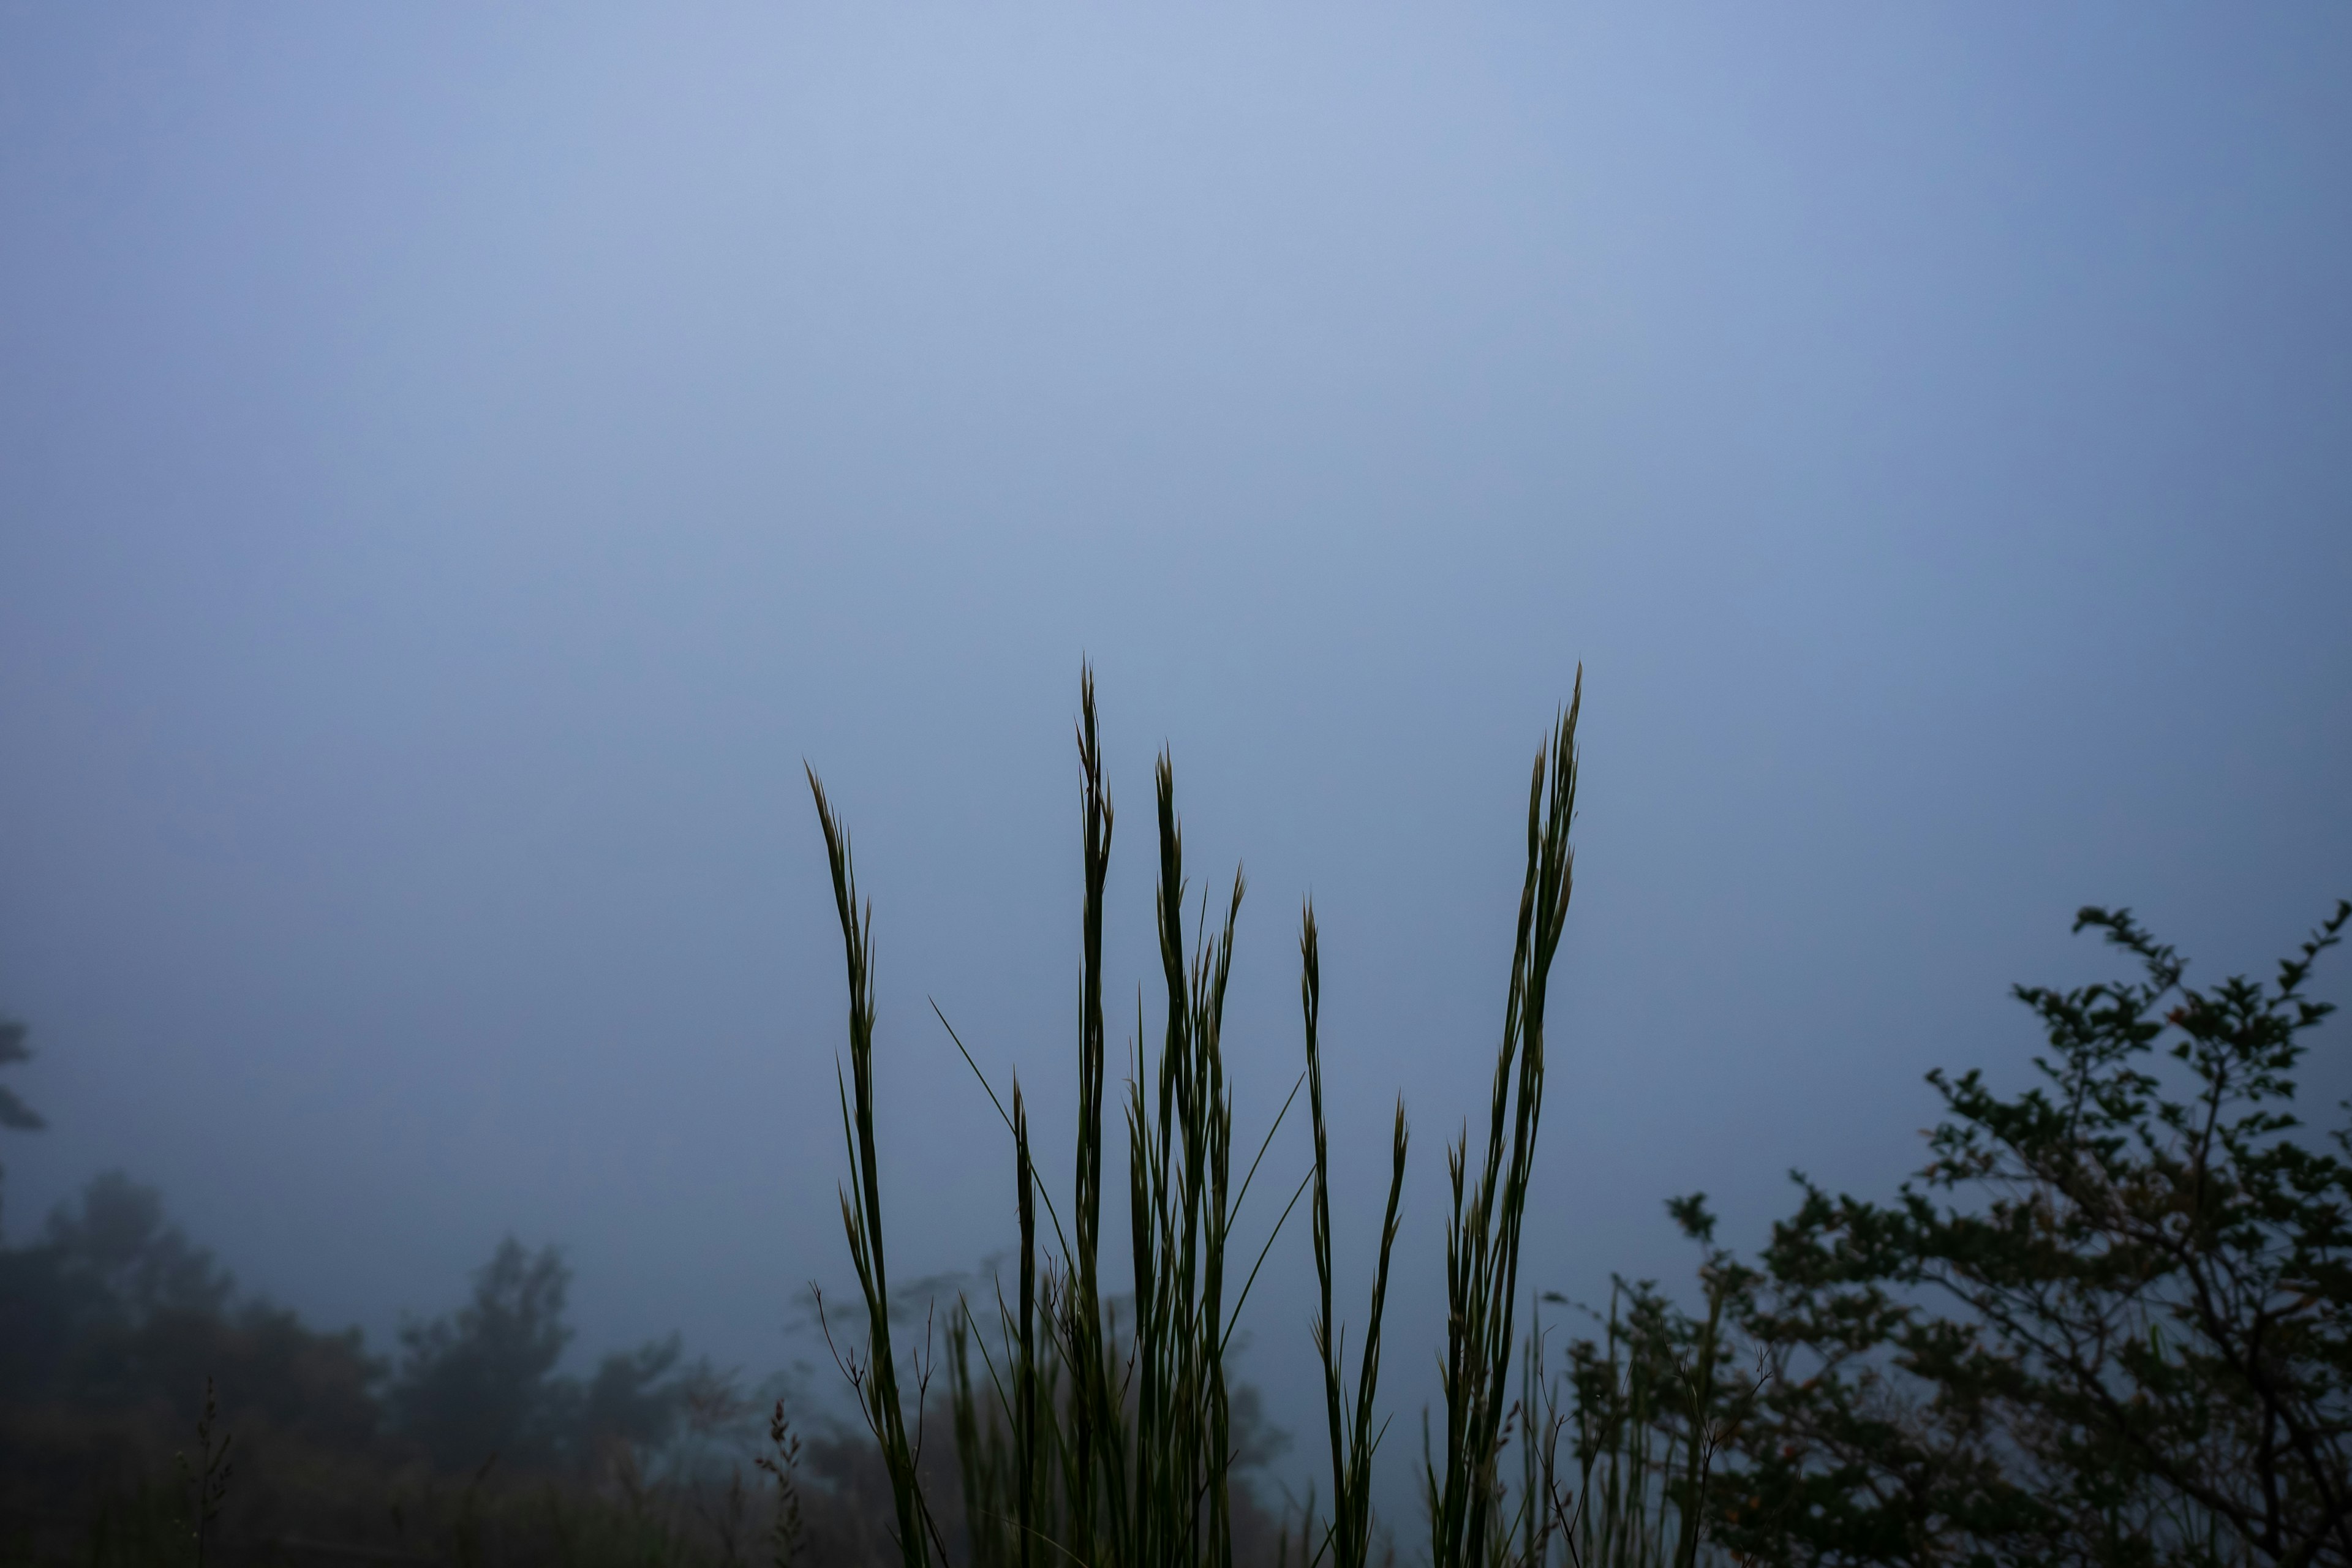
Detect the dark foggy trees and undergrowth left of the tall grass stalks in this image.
<box><xmin>0</xmin><ymin>1173</ymin><xmax>1275</xmax><ymax>1568</ymax></box>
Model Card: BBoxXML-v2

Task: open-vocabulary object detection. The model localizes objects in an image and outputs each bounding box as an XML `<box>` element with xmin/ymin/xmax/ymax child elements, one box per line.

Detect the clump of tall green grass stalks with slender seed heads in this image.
<box><xmin>809</xmin><ymin>670</ymin><xmax>1731</xmax><ymax>1568</ymax></box>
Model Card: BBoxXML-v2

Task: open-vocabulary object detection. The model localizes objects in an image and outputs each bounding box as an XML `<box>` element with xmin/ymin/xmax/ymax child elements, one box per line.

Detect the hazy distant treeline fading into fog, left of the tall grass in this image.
<box><xmin>0</xmin><ymin>1173</ymin><xmax>837</xmax><ymax>1561</ymax></box>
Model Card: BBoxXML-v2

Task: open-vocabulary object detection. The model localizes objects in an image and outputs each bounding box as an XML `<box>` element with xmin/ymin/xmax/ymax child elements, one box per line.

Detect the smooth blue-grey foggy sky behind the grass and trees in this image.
<box><xmin>0</xmin><ymin>5</ymin><xmax>2352</xmax><ymax>1495</ymax></box>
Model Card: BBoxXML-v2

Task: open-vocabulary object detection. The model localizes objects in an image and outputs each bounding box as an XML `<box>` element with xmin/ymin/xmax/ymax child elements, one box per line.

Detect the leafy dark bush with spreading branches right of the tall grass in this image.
<box><xmin>1578</xmin><ymin>903</ymin><xmax>2352</xmax><ymax>1568</ymax></box>
